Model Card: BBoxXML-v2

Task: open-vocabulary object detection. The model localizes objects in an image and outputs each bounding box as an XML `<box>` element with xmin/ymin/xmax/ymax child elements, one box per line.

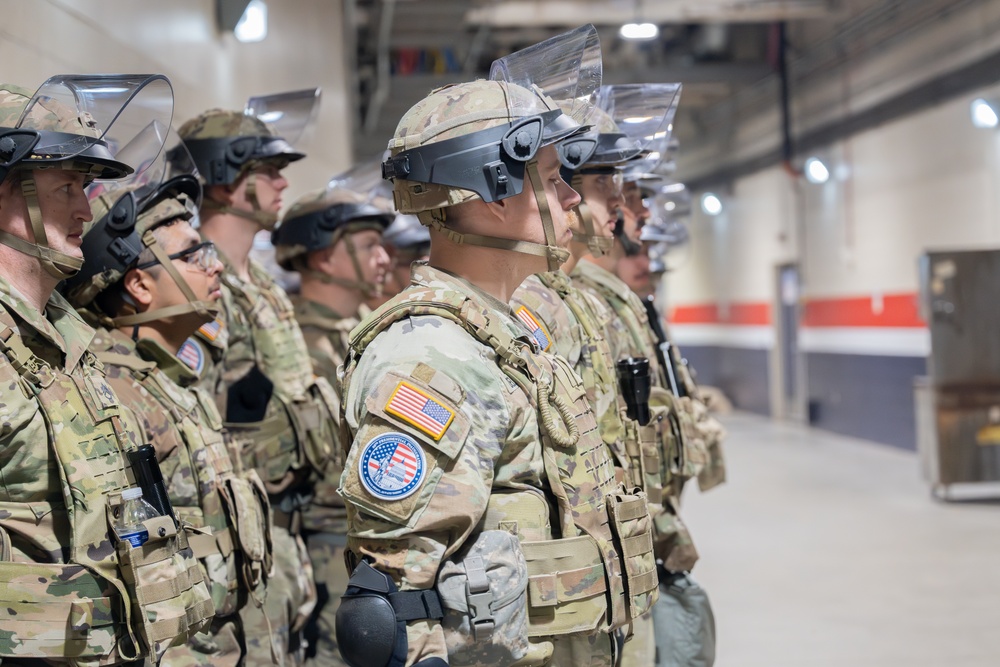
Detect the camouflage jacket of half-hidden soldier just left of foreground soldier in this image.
<box><xmin>292</xmin><ymin>296</ymin><xmax>358</xmax><ymax>535</ymax></box>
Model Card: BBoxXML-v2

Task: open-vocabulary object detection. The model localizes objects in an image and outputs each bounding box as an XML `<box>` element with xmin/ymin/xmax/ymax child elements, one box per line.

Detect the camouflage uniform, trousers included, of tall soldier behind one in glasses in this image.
<box><xmin>182</xmin><ymin>253</ymin><xmax>334</xmax><ymax>664</ymax></box>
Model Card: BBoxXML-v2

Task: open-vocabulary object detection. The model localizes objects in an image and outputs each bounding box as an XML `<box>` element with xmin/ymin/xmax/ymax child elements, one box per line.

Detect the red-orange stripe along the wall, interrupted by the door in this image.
<box><xmin>669</xmin><ymin>292</ymin><xmax>927</xmax><ymax>328</ymax></box>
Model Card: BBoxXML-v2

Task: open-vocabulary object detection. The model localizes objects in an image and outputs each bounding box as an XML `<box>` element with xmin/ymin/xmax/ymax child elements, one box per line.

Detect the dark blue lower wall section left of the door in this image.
<box><xmin>681</xmin><ymin>345</ymin><xmax>771</xmax><ymax>415</ymax></box>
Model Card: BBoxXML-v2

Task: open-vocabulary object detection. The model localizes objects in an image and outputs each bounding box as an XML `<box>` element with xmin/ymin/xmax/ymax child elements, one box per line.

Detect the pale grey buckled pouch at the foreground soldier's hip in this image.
<box><xmin>437</xmin><ymin>530</ymin><xmax>528</xmax><ymax>667</ymax></box>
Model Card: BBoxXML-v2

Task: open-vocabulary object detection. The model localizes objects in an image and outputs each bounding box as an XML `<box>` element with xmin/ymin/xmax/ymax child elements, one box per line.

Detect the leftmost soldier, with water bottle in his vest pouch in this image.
<box><xmin>0</xmin><ymin>75</ymin><xmax>214</xmax><ymax>665</ymax></box>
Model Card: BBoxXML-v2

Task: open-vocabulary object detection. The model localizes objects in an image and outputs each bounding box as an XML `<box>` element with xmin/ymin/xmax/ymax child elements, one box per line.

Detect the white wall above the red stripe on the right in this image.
<box><xmin>667</xmin><ymin>90</ymin><xmax>1000</xmax><ymax>312</ymax></box>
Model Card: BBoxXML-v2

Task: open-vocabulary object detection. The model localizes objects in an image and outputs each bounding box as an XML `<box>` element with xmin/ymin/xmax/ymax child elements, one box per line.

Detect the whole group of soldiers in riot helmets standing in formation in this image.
<box><xmin>0</xmin><ymin>20</ymin><xmax>725</xmax><ymax>667</ymax></box>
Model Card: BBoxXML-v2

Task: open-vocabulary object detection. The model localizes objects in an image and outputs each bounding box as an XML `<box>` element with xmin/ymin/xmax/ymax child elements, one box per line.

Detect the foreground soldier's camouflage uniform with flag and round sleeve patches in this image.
<box><xmin>340</xmin><ymin>263</ymin><xmax>656</xmax><ymax>666</ymax></box>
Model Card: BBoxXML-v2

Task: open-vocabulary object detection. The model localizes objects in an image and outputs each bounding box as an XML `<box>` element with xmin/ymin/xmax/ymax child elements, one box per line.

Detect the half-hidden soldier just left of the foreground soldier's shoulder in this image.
<box><xmin>271</xmin><ymin>183</ymin><xmax>393</xmax><ymax>665</ymax></box>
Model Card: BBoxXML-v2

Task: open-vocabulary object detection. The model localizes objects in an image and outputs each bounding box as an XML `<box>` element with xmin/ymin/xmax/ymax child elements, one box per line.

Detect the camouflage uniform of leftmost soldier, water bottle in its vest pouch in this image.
<box><xmin>0</xmin><ymin>278</ymin><xmax>214</xmax><ymax>664</ymax></box>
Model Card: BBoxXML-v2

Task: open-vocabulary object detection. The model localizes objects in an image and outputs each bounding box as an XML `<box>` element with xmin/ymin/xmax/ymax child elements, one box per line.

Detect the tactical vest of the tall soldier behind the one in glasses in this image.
<box><xmin>224</xmin><ymin>264</ymin><xmax>337</xmax><ymax>498</ymax></box>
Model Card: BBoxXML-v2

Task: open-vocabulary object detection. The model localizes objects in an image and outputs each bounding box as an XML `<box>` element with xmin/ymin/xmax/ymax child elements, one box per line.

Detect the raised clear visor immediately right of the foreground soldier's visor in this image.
<box><xmin>595</xmin><ymin>83</ymin><xmax>681</xmax><ymax>164</ymax></box>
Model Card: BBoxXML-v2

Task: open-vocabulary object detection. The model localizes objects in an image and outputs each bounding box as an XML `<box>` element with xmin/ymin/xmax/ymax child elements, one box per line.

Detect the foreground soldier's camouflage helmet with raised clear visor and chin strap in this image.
<box><xmin>382</xmin><ymin>25</ymin><xmax>601</xmax><ymax>270</ymax></box>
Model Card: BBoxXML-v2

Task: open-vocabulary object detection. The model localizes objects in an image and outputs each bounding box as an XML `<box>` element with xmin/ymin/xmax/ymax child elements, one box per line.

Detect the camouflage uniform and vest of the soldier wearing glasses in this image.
<box><xmin>91</xmin><ymin>330</ymin><xmax>271</xmax><ymax>667</ymax></box>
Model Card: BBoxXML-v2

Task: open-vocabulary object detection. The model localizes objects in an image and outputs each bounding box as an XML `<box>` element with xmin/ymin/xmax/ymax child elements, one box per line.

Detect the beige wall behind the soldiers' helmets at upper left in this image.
<box><xmin>0</xmin><ymin>0</ymin><xmax>353</xmax><ymax>205</ymax></box>
